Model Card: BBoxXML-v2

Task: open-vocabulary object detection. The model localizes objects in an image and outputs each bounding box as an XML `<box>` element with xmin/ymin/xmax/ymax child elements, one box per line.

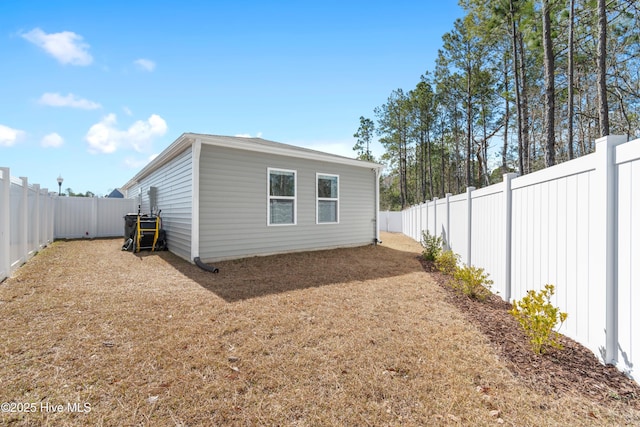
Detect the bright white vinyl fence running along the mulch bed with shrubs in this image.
<box><xmin>402</xmin><ymin>136</ymin><xmax>640</xmax><ymax>379</ymax></box>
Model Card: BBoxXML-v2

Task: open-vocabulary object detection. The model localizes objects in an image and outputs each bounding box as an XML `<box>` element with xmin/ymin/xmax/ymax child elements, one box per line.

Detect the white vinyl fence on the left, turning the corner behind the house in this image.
<box><xmin>0</xmin><ymin>167</ymin><xmax>137</xmax><ymax>281</ymax></box>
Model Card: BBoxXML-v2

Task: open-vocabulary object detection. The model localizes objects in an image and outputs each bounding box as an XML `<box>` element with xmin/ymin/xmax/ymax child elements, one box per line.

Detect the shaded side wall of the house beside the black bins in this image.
<box><xmin>127</xmin><ymin>147</ymin><xmax>193</xmax><ymax>259</ymax></box>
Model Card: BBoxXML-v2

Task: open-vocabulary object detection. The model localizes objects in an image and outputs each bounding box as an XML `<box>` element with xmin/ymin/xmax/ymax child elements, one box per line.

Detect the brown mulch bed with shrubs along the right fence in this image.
<box><xmin>419</xmin><ymin>256</ymin><xmax>640</xmax><ymax>409</ymax></box>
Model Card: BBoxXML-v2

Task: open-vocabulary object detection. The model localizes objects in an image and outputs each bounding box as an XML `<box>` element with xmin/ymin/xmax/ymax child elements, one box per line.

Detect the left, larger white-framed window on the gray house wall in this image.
<box><xmin>267</xmin><ymin>168</ymin><xmax>296</xmax><ymax>225</ymax></box>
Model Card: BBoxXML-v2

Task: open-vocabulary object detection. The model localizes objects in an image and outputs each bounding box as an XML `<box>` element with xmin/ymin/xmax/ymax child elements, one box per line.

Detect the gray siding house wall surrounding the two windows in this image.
<box><xmin>199</xmin><ymin>144</ymin><xmax>378</xmax><ymax>262</ymax></box>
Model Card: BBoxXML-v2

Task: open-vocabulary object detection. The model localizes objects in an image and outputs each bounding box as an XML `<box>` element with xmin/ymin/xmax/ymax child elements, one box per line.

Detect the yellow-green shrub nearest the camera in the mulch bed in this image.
<box><xmin>509</xmin><ymin>285</ymin><xmax>567</xmax><ymax>354</ymax></box>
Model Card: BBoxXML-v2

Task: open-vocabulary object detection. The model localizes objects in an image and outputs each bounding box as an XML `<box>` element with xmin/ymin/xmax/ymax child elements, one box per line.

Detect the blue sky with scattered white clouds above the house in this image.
<box><xmin>0</xmin><ymin>0</ymin><xmax>463</xmax><ymax>195</ymax></box>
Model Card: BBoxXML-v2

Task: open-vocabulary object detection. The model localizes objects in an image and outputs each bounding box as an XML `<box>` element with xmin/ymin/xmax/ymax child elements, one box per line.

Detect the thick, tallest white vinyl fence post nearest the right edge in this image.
<box><xmin>596</xmin><ymin>135</ymin><xmax>627</xmax><ymax>365</ymax></box>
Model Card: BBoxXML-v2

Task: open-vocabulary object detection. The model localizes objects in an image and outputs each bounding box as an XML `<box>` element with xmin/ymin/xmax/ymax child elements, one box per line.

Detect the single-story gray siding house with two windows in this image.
<box><xmin>122</xmin><ymin>133</ymin><xmax>382</xmax><ymax>262</ymax></box>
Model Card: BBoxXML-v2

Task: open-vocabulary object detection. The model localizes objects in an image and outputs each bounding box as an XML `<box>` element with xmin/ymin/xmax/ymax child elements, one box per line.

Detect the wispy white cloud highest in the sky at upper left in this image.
<box><xmin>22</xmin><ymin>28</ymin><xmax>93</xmax><ymax>65</ymax></box>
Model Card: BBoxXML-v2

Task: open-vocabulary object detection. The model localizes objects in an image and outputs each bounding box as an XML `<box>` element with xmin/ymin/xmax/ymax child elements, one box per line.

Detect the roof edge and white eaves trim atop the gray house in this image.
<box><xmin>122</xmin><ymin>133</ymin><xmax>383</xmax><ymax>190</ymax></box>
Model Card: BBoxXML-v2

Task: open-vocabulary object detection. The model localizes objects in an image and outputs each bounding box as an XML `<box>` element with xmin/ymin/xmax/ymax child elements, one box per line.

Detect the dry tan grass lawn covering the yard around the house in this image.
<box><xmin>0</xmin><ymin>234</ymin><xmax>640</xmax><ymax>426</ymax></box>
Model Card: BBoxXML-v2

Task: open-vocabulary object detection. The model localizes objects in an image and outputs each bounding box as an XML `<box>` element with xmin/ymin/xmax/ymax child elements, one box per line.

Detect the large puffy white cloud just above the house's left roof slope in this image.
<box><xmin>85</xmin><ymin>113</ymin><xmax>167</xmax><ymax>153</ymax></box>
